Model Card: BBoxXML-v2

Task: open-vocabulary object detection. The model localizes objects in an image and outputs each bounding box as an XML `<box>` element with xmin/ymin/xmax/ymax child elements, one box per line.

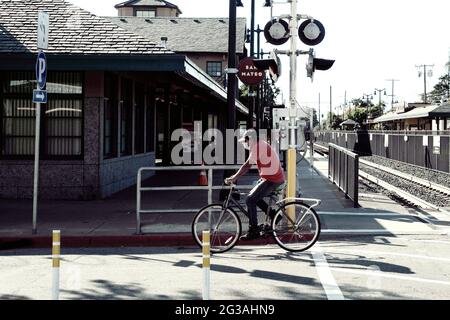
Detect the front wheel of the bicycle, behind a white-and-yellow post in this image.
<box><xmin>192</xmin><ymin>204</ymin><xmax>242</xmax><ymax>253</ymax></box>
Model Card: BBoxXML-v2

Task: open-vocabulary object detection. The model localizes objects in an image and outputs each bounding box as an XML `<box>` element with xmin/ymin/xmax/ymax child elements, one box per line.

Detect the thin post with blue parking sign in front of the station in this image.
<box><xmin>32</xmin><ymin>11</ymin><xmax>49</xmax><ymax>234</ymax></box>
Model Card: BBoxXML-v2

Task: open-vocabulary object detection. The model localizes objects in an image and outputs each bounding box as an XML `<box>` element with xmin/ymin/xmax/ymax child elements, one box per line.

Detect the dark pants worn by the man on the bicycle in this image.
<box><xmin>246</xmin><ymin>180</ymin><xmax>282</xmax><ymax>227</ymax></box>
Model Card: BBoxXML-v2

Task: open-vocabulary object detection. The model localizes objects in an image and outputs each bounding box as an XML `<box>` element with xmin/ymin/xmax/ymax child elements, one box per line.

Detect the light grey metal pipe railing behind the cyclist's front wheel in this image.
<box><xmin>136</xmin><ymin>166</ymin><xmax>254</xmax><ymax>234</ymax></box>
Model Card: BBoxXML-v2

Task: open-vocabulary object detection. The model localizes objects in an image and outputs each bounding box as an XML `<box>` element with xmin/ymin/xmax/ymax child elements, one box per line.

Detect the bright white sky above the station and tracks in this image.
<box><xmin>69</xmin><ymin>0</ymin><xmax>450</xmax><ymax>114</ymax></box>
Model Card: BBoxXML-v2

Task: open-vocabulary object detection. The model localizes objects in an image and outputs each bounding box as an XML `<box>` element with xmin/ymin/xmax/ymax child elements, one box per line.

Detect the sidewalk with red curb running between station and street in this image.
<box><xmin>0</xmin><ymin>157</ymin><xmax>433</xmax><ymax>250</ymax></box>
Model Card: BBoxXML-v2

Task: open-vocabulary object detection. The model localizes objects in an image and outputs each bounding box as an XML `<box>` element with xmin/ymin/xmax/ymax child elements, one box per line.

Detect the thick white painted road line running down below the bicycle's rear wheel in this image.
<box><xmin>312</xmin><ymin>243</ymin><xmax>345</xmax><ymax>300</ymax></box>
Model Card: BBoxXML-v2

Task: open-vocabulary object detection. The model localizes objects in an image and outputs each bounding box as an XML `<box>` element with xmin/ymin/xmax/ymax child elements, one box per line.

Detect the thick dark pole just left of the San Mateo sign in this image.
<box><xmin>227</xmin><ymin>0</ymin><xmax>237</xmax><ymax>130</ymax></box>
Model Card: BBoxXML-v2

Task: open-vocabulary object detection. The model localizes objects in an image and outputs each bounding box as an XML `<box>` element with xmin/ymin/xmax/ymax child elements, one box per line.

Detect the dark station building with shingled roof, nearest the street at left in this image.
<box><xmin>0</xmin><ymin>0</ymin><xmax>248</xmax><ymax>200</ymax></box>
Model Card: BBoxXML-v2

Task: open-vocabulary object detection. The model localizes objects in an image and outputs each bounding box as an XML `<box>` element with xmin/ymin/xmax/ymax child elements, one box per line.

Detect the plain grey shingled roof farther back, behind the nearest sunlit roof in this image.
<box><xmin>105</xmin><ymin>17</ymin><xmax>246</xmax><ymax>54</ymax></box>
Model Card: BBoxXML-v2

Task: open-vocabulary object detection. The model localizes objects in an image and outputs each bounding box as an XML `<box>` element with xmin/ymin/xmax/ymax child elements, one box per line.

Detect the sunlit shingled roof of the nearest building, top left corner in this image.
<box><xmin>0</xmin><ymin>0</ymin><xmax>172</xmax><ymax>55</ymax></box>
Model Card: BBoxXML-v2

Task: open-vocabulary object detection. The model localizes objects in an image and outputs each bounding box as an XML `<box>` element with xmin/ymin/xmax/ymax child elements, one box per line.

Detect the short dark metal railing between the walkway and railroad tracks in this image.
<box><xmin>328</xmin><ymin>143</ymin><xmax>359</xmax><ymax>208</ymax></box>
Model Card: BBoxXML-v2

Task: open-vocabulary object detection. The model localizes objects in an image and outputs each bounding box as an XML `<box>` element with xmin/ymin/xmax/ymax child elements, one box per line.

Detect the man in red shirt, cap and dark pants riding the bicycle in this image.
<box><xmin>225</xmin><ymin>130</ymin><xmax>286</xmax><ymax>240</ymax></box>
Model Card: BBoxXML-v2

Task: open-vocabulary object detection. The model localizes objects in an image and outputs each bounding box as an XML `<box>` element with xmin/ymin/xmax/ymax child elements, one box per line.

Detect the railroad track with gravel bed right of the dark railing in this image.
<box><xmin>314</xmin><ymin>144</ymin><xmax>450</xmax><ymax>214</ymax></box>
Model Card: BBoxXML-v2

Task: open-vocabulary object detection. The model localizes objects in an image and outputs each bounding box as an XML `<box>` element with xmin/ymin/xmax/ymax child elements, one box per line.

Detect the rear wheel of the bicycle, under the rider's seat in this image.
<box><xmin>272</xmin><ymin>201</ymin><xmax>320</xmax><ymax>252</ymax></box>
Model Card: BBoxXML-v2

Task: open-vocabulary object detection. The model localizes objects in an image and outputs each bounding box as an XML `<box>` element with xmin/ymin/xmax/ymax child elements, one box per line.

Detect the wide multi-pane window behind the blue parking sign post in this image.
<box><xmin>0</xmin><ymin>72</ymin><xmax>84</xmax><ymax>159</ymax></box>
